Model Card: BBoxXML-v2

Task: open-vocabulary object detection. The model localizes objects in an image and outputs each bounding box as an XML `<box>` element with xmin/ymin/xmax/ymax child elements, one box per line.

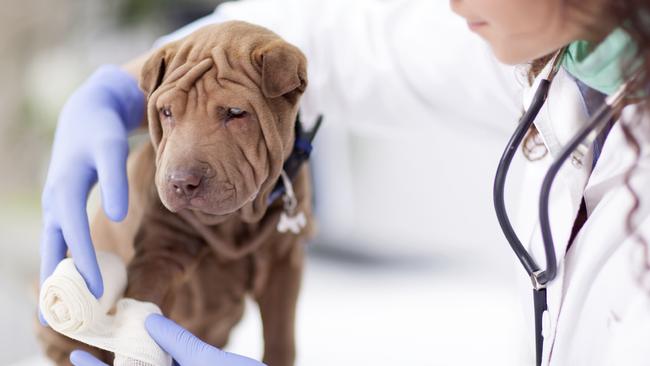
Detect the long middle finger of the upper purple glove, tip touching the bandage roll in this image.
<box><xmin>57</xmin><ymin>175</ymin><xmax>104</xmax><ymax>298</ymax></box>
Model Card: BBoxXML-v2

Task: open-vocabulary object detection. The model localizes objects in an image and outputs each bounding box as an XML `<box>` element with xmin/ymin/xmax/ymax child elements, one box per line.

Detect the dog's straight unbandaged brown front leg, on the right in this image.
<box><xmin>256</xmin><ymin>243</ymin><xmax>304</xmax><ymax>366</ymax></box>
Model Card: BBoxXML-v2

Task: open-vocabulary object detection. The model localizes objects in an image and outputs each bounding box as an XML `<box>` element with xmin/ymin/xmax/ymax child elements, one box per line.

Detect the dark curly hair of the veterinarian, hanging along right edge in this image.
<box><xmin>522</xmin><ymin>0</ymin><xmax>650</xmax><ymax>281</ymax></box>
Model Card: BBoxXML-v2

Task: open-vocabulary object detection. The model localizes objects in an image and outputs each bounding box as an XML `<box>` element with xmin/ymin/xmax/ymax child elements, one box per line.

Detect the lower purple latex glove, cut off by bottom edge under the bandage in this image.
<box><xmin>70</xmin><ymin>314</ymin><xmax>264</xmax><ymax>366</ymax></box>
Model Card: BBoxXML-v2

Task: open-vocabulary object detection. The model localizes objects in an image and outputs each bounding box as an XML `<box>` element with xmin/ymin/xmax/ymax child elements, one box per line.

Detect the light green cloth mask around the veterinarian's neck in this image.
<box><xmin>562</xmin><ymin>28</ymin><xmax>636</xmax><ymax>95</ymax></box>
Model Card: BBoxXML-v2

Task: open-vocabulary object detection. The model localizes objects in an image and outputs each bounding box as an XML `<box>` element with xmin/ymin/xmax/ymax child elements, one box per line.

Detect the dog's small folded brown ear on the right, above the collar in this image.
<box><xmin>254</xmin><ymin>40</ymin><xmax>307</xmax><ymax>99</ymax></box>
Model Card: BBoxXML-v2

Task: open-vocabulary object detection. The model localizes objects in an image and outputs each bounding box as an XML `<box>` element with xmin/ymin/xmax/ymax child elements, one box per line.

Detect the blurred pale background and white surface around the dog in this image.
<box><xmin>0</xmin><ymin>0</ymin><xmax>532</xmax><ymax>366</ymax></box>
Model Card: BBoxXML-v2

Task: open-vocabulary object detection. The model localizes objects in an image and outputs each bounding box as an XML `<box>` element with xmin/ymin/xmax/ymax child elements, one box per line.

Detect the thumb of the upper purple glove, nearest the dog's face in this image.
<box><xmin>96</xmin><ymin>137</ymin><xmax>129</xmax><ymax>221</ymax></box>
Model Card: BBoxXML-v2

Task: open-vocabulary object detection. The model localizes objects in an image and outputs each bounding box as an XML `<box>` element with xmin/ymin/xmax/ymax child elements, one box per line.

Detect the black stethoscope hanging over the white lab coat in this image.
<box><xmin>493</xmin><ymin>50</ymin><xmax>632</xmax><ymax>366</ymax></box>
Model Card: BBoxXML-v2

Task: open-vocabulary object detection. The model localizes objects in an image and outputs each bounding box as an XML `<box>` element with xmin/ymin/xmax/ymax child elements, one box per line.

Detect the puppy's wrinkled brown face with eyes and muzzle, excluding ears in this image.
<box><xmin>151</xmin><ymin>71</ymin><xmax>260</xmax><ymax>215</ymax></box>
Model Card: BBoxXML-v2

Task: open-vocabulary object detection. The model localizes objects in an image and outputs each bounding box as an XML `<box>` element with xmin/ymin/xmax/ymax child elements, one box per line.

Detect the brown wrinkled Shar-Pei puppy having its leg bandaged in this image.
<box><xmin>40</xmin><ymin>22</ymin><xmax>312</xmax><ymax>366</ymax></box>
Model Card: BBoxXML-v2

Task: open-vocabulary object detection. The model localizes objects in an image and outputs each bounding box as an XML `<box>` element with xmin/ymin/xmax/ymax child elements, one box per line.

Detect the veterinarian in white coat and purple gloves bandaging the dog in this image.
<box><xmin>41</xmin><ymin>0</ymin><xmax>650</xmax><ymax>366</ymax></box>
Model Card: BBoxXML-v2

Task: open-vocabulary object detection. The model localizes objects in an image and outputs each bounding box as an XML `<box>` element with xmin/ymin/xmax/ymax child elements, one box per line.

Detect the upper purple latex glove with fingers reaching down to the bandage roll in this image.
<box><xmin>41</xmin><ymin>65</ymin><xmax>145</xmax><ymax>308</ymax></box>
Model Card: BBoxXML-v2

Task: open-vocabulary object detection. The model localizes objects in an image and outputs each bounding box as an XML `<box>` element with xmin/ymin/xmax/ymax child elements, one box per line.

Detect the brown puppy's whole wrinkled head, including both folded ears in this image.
<box><xmin>141</xmin><ymin>22</ymin><xmax>306</xmax><ymax>221</ymax></box>
